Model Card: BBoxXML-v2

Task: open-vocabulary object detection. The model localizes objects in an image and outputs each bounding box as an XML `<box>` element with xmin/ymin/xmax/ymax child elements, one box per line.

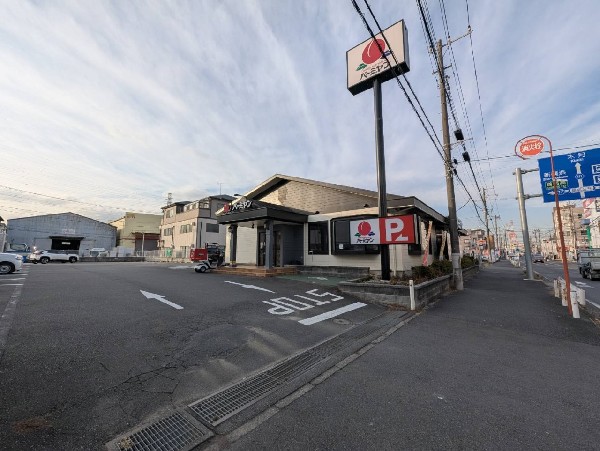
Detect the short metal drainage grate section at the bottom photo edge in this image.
<box><xmin>116</xmin><ymin>413</ymin><xmax>208</xmax><ymax>451</ymax></box>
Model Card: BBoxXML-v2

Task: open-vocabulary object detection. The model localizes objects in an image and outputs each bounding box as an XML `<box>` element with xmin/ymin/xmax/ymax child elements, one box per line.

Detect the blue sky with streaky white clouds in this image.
<box><xmin>0</xmin><ymin>0</ymin><xmax>600</xmax><ymax>240</ymax></box>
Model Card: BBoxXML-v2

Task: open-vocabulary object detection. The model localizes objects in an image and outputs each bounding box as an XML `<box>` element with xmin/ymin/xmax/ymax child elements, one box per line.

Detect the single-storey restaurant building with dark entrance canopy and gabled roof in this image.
<box><xmin>218</xmin><ymin>174</ymin><xmax>448</xmax><ymax>273</ymax></box>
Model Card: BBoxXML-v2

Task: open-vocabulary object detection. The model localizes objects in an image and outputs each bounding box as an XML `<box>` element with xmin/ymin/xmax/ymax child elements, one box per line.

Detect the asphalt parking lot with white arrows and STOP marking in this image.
<box><xmin>0</xmin><ymin>263</ymin><xmax>388</xmax><ymax>450</ymax></box>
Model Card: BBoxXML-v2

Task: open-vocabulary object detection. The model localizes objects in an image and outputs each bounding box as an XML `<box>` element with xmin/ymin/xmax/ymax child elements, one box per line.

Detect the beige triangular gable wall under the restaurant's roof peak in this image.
<box><xmin>259</xmin><ymin>181</ymin><xmax>377</xmax><ymax>213</ymax></box>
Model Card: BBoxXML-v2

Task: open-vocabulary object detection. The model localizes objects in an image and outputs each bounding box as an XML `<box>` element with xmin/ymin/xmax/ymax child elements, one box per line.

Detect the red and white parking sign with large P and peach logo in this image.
<box><xmin>350</xmin><ymin>215</ymin><xmax>416</xmax><ymax>244</ymax></box>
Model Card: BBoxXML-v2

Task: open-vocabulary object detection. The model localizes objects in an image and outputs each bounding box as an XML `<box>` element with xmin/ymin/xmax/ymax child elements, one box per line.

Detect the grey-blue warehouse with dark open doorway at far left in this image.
<box><xmin>7</xmin><ymin>213</ymin><xmax>117</xmax><ymax>255</ymax></box>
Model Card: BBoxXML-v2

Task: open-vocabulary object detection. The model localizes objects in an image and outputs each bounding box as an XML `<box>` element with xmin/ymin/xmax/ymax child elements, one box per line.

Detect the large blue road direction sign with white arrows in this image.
<box><xmin>538</xmin><ymin>148</ymin><xmax>600</xmax><ymax>202</ymax></box>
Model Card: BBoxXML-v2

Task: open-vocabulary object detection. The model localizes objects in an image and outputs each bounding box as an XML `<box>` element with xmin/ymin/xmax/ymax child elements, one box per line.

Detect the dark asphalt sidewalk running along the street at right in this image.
<box><xmin>223</xmin><ymin>262</ymin><xmax>600</xmax><ymax>450</ymax></box>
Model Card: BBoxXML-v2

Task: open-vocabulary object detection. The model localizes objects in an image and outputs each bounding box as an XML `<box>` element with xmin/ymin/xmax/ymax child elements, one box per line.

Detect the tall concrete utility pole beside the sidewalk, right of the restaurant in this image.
<box><xmin>437</xmin><ymin>39</ymin><xmax>464</xmax><ymax>290</ymax></box>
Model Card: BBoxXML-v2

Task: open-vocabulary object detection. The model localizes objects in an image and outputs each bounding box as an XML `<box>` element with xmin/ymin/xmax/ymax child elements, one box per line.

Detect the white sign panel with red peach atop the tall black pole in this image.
<box><xmin>346</xmin><ymin>20</ymin><xmax>410</xmax><ymax>95</ymax></box>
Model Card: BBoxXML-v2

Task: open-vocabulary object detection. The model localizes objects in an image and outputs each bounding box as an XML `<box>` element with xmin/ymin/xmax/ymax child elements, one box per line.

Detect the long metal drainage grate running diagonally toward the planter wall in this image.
<box><xmin>189</xmin><ymin>312</ymin><xmax>406</xmax><ymax>426</ymax></box>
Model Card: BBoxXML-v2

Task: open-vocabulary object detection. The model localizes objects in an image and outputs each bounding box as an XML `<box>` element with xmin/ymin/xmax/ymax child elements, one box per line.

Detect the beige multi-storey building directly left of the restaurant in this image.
<box><xmin>159</xmin><ymin>194</ymin><xmax>234</xmax><ymax>259</ymax></box>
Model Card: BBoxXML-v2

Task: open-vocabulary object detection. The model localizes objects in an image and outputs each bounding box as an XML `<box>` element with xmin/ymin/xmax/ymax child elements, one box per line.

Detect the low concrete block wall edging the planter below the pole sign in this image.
<box><xmin>338</xmin><ymin>266</ymin><xmax>479</xmax><ymax>309</ymax></box>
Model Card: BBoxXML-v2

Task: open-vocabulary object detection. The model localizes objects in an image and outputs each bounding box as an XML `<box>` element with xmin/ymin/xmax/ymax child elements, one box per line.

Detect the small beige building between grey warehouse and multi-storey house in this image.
<box><xmin>109</xmin><ymin>212</ymin><xmax>162</xmax><ymax>255</ymax></box>
